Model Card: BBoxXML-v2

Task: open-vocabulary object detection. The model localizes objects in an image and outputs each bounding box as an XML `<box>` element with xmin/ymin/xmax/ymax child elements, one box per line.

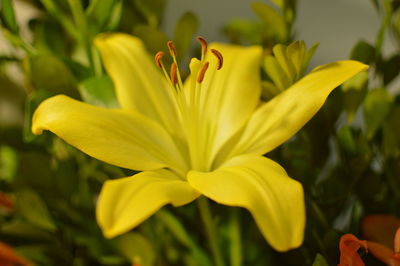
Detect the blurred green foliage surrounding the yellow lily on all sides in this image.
<box><xmin>0</xmin><ymin>0</ymin><xmax>400</xmax><ymax>266</ymax></box>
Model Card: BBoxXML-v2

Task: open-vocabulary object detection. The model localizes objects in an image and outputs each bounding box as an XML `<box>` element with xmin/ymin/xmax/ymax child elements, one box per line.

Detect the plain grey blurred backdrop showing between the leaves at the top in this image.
<box><xmin>162</xmin><ymin>0</ymin><xmax>384</xmax><ymax>66</ymax></box>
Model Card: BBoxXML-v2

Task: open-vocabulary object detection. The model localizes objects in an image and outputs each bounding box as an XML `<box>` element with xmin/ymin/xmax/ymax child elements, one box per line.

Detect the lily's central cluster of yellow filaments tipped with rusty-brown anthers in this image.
<box><xmin>155</xmin><ymin>37</ymin><xmax>224</xmax><ymax>171</ymax></box>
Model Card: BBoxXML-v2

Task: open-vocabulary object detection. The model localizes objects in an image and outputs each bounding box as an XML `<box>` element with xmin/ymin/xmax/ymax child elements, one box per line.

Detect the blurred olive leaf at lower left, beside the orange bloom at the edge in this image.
<box><xmin>16</xmin><ymin>189</ymin><xmax>57</xmax><ymax>232</ymax></box>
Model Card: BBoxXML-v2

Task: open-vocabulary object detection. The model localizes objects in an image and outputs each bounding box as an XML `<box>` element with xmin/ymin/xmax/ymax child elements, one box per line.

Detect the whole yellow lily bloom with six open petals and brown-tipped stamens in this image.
<box><xmin>32</xmin><ymin>34</ymin><xmax>367</xmax><ymax>251</ymax></box>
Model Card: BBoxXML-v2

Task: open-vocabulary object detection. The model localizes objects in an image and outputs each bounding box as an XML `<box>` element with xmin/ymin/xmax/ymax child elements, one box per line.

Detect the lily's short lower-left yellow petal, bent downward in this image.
<box><xmin>96</xmin><ymin>169</ymin><xmax>199</xmax><ymax>238</ymax></box>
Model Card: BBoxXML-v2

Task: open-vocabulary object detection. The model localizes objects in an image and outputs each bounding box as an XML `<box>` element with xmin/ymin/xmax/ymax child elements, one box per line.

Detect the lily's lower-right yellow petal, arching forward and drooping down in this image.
<box><xmin>188</xmin><ymin>154</ymin><xmax>305</xmax><ymax>251</ymax></box>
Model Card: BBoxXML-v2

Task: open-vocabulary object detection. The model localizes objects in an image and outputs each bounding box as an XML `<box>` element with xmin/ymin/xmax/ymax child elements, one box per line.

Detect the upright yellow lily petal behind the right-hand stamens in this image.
<box><xmin>195</xmin><ymin>44</ymin><xmax>262</xmax><ymax>163</ymax></box>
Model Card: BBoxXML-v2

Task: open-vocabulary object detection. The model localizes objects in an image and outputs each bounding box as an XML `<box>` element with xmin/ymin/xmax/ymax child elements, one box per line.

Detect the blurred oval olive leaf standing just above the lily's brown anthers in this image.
<box><xmin>174</xmin><ymin>12</ymin><xmax>199</xmax><ymax>59</ymax></box>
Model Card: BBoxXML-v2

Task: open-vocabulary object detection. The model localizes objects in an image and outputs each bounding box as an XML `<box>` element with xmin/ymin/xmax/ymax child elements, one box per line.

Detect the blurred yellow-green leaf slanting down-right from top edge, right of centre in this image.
<box><xmin>251</xmin><ymin>2</ymin><xmax>288</xmax><ymax>42</ymax></box>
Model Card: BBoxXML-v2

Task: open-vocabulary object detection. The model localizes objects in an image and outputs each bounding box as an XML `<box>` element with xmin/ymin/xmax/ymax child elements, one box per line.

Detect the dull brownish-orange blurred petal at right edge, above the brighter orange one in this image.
<box><xmin>362</xmin><ymin>215</ymin><xmax>400</xmax><ymax>249</ymax></box>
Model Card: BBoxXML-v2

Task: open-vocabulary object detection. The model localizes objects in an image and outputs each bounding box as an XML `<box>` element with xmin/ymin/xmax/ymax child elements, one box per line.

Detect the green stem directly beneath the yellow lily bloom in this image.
<box><xmin>197</xmin><ymin>197</ymin><xmax>224</xmax><ymax>266</ymax></box>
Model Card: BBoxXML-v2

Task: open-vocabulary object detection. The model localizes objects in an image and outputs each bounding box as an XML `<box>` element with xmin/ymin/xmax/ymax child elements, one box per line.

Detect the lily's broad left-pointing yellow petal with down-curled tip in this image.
<box><xmin>32</xmin><ymin>95</ymin><xmax>183</xmax><ymax>170</ymax></box>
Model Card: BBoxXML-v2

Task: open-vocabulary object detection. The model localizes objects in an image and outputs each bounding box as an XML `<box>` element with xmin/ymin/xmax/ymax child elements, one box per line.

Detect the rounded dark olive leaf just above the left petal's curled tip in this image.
<box><xmin>28</xmin><ymin>55</ymin><xmax>77</xmax><ymax>95</ymax></box>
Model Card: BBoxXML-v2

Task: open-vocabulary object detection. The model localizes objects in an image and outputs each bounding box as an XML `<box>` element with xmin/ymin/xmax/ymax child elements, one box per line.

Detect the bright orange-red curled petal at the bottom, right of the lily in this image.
<box><xmin>338</xmin><ymin>234</ymin><xmax>368</xmax><ymax>266</ymax></box>
